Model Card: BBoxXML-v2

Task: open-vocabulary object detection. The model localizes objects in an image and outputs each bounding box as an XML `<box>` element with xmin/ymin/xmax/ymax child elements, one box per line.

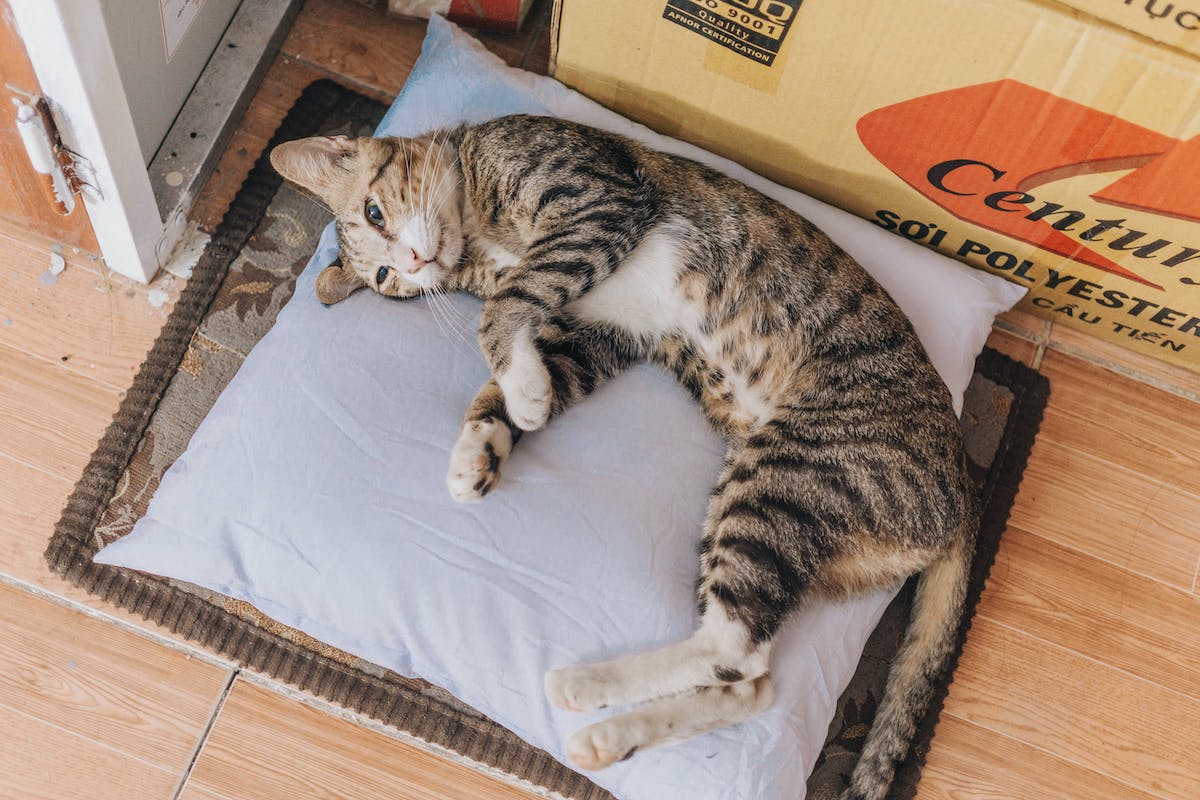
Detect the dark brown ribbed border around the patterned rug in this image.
<box><xmin>44</xmin><ymin>78</ymin><xmax>1049</xmax><ymax>800</ymax></box>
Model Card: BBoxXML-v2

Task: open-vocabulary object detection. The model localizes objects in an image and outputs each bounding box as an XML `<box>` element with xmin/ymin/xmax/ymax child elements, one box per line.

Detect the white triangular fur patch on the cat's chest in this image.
<box><xmin>566</xmin><ymin>223</ymin><xmax>703</xmax><ymax>339</ymax></box>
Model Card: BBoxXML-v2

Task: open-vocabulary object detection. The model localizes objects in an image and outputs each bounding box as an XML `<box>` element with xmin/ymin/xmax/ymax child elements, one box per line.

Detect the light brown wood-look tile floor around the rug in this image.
<box><xmin>0</xmin><ymin>0</ymin><xmax>1200</xmax><ymax>800</ymax></box>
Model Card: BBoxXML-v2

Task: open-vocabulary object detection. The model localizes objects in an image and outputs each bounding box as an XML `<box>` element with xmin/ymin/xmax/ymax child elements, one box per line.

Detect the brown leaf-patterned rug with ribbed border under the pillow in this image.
<box><xmin>46</xmin><ymin>80</ymin><xmax>1049</xmax><ymax>800</ymax></box>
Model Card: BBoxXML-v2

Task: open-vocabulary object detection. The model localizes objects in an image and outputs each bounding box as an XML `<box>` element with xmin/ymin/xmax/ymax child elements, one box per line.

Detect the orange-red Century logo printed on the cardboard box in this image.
<box><xmin>858</xmin><ymin>79</ymin><xmax>1200</xmax><ymax>289</ymax></box>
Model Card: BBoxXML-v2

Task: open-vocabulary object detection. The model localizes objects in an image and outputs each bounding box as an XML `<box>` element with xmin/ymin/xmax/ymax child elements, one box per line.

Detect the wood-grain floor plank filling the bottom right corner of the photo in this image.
<box><xmin>946</xmin><ymin>618</ymin><xmax>1200</xmax><ymax>800</ymax></box>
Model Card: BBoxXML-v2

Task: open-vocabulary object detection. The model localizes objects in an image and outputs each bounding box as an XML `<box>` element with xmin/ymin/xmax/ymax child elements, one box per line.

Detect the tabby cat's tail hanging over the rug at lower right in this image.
<box><xmin>841</xmin><ymin>515</ymin><xmax>976</xmax><ymax>800</ymax></box>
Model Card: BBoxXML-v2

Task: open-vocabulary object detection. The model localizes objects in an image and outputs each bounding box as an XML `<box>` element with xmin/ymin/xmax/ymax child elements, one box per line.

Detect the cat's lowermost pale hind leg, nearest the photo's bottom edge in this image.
<box><xmin>566</xmin><ymin>675</ymin><xmax>774</xmax><ymax>770</ymax></box>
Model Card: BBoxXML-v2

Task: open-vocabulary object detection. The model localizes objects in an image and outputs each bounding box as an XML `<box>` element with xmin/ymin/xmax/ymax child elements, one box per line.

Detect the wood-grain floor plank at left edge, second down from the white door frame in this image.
<box><xmin>0</xmin><ymin>343</ymin><xmax>122</xmax><ymax>481</ymax></box>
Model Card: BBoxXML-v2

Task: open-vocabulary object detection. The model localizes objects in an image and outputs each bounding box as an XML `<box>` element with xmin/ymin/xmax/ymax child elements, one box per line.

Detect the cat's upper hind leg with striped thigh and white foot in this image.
<box><xmin>545</xmin><ymin>412</ymin><xmax>868</xmax><ymax>710</ymax></box>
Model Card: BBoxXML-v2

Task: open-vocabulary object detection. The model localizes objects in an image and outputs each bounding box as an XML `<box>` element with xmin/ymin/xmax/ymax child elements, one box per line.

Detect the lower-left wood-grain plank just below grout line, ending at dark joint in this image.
<box><xmin>0</xmin><ymin>585</ymin><xmax>229</xmax><ymax>774</ymax></box>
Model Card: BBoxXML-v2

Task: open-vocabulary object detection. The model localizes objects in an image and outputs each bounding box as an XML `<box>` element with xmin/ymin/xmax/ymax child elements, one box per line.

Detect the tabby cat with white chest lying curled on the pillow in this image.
<box><xmin>271</xmin><ymin>116</ymin><xmax>977</xmax><ymax>799</ymax></box>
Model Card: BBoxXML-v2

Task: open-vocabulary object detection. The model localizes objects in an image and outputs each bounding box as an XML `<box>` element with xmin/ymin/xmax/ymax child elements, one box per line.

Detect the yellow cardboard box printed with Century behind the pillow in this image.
<box><xmin>552</xmin><ymin>0</ymin><xmax>1200</xmax><ymax>369</ymax></box>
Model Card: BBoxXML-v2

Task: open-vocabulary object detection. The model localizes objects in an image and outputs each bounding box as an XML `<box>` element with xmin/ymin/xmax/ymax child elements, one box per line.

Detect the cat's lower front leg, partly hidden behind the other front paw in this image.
<box><xmin>446</xmin><ymin>318</ymin><xmax>641</xmax><ymax>503</ymax></box>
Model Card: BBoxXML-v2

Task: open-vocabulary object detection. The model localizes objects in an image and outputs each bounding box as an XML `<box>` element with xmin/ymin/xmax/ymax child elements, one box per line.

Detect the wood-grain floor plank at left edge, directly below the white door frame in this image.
<box><xmin>0</xmin><ymin>221</ymin><xmax>182</xmax><ymax>390</ymax></box>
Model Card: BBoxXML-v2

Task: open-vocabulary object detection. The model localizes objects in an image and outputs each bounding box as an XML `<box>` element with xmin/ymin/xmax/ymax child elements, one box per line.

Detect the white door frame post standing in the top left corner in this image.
<box><xmin>10</xmin><ymin>0</ymin><xmax>174</xmax><ymax>283</ymax></box>
